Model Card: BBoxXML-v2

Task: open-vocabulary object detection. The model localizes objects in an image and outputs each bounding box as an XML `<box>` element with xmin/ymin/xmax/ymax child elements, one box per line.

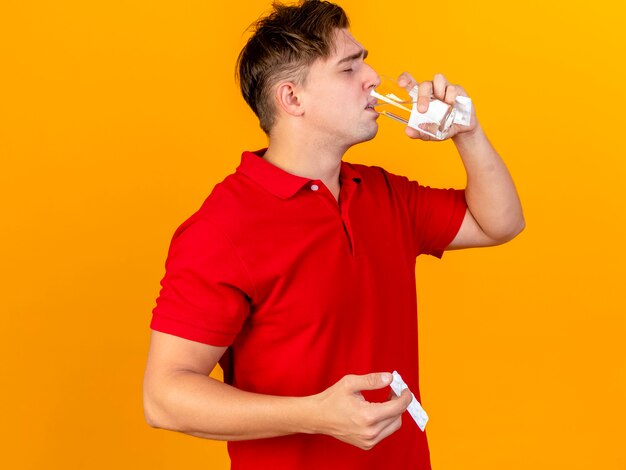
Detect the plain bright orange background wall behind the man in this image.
<box><xmin>0</xmin><ymin>0</ymin><xmax>626</xmax><ymax>470</ymax></box>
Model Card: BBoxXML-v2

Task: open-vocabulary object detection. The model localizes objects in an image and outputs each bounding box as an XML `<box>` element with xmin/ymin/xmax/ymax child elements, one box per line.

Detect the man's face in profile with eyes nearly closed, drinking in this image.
<box><xmin>301</xmin><ymin>29</ymin><xmax>380</xmax><ymax>148</ymax></box>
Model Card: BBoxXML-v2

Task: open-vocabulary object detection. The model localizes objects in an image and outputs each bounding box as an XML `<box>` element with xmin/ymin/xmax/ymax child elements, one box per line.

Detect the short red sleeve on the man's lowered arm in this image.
<box><xmin>150</xmin><ymin>217</ymin><xmax>253</xmax><ymax>346</ymax></box>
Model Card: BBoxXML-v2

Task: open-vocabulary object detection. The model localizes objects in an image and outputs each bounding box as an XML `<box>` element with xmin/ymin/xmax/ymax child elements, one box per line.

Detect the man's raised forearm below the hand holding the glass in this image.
<box><xmin>452</xmin><ymin>124</ymin><xmax>524</xmax><ymax>242</ymax></box>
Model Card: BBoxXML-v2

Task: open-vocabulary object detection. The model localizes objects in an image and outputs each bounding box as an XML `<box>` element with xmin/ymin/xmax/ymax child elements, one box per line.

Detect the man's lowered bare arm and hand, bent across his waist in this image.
<box><xmin>144</xmin><ymin>331</ymin><xmax>411</xmax><ymax>449</ymax></box>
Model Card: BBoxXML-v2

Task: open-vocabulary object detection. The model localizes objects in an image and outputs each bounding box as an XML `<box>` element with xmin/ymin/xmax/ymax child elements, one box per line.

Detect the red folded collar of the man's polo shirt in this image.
<box><xmin>237</xmin><ymin>149</ymin><xmax>361</xmax><ymax>199</ymax></box>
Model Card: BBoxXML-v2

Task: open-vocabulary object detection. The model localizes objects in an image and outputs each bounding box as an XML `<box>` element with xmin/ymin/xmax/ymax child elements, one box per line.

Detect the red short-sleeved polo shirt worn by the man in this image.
<box><xmin>151</xmin><ymin>152</ymin><xmax>466</xmax><ymax>470</ymax></box>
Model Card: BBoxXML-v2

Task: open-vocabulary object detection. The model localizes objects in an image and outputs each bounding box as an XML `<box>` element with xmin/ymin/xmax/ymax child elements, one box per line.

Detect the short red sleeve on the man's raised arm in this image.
<box><xmin>380</xmin><ymin>174</ymin><xmax>467</xmax><ymax>258</ymax></box>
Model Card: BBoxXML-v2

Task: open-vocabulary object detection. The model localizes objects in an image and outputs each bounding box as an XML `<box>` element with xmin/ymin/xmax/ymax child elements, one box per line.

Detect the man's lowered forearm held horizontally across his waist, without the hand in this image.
<box><xmin>144</xmin><ymin>371</ymin><xmax>315</xmax><ymax>441</ymax></box>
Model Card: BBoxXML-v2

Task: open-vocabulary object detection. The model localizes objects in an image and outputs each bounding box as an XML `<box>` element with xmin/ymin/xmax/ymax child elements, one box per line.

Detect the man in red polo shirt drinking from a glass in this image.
<box><xmin>144</xmin><ymin>0</ymin><xmax>524</xmax><ymax>470</ymax></box>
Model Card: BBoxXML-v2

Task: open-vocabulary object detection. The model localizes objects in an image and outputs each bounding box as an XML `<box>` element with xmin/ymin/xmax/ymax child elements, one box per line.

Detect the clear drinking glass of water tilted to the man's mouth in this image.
<box><xmin>371</xmin><ymin>75</ymin><xmax>456</xmax><ymax>140</ymax></box>
